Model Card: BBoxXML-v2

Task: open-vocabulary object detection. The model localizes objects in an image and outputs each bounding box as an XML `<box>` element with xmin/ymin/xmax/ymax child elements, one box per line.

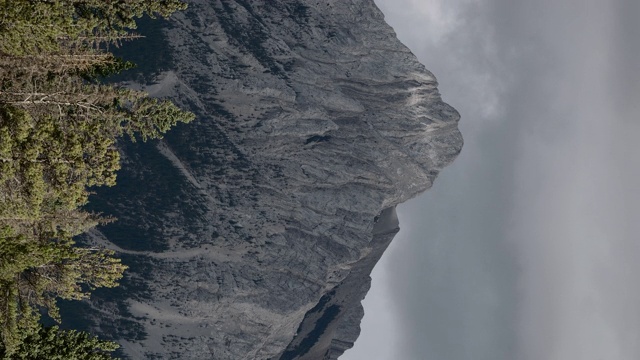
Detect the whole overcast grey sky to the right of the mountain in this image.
<box><xmin>341</xmin><ymin>0</ymin><xmax>640</xmax><ymax>360</ymax></box>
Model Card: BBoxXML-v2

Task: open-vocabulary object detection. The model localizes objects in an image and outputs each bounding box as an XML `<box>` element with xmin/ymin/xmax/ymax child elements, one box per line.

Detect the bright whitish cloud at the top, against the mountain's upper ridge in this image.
<box><xmin>376</xmin><ymin>0</ymin><xmax>506</xmax><ymax>120</ymax></box>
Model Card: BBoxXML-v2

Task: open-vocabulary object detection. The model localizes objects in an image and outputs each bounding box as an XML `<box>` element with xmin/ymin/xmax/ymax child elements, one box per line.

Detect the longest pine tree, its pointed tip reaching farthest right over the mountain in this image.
<box><xmin>0</xmin><ymin>70</ymin><xmax>194</xmax><ymax>219</ymax></box>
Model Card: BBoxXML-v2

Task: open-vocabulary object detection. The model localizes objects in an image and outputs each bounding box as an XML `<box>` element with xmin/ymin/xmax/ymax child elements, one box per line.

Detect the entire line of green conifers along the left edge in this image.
<box><xmin>0</xmin><ymin>0</ymin><xmax>194</xmax><ymax>360</ymax></box>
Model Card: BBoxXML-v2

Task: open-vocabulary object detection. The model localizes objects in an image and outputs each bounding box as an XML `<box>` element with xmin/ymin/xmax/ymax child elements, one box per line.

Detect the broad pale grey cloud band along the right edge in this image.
<box><xmin>509</xmin><ymin>2</ymin><xmax>640</xmax><ymax>359</ymax></box>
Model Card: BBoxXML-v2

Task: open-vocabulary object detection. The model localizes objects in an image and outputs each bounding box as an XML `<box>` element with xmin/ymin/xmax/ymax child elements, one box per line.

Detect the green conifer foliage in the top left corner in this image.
<box><xmin>0</xmin><ymin>0</ymin><xmax>187</xmax><ymax>56</ymax></box>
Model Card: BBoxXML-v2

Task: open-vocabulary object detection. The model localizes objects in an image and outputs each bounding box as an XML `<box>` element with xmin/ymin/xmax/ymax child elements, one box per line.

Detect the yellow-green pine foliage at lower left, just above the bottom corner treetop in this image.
<box><xmin>0</xmin><ymin>219</ymin><xmax>126</xmax><ymax>353</ymax></box>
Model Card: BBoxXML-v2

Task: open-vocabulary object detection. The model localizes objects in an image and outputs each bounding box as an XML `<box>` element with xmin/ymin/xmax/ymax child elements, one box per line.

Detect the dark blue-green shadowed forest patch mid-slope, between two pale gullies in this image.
<box><xmin>87</xmin><ymin>142</ymin><xmax>206</xmax><ymax>251</ymax></box>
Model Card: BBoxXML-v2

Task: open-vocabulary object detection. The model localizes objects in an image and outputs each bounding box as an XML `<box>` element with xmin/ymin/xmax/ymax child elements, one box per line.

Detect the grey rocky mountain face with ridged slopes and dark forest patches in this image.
<box><xmin>75</xmin><ymin>0</ymin><xmax>462</xmax><ymax>360</ymax></box>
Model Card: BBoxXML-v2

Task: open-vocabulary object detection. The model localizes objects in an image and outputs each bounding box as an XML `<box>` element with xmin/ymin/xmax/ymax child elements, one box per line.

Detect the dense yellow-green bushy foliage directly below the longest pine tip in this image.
<box><xmin>0</xmin><ymin>106</ymin><xmax>120</xmax><ymax>220</ymax></box>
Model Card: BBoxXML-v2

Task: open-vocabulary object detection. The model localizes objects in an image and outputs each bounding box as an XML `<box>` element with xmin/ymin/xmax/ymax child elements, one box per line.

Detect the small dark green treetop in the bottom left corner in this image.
<box><xmin>0</xmin><ymin>326</ymin><xmax>118</xmax><ymax>360</ymax></box>
